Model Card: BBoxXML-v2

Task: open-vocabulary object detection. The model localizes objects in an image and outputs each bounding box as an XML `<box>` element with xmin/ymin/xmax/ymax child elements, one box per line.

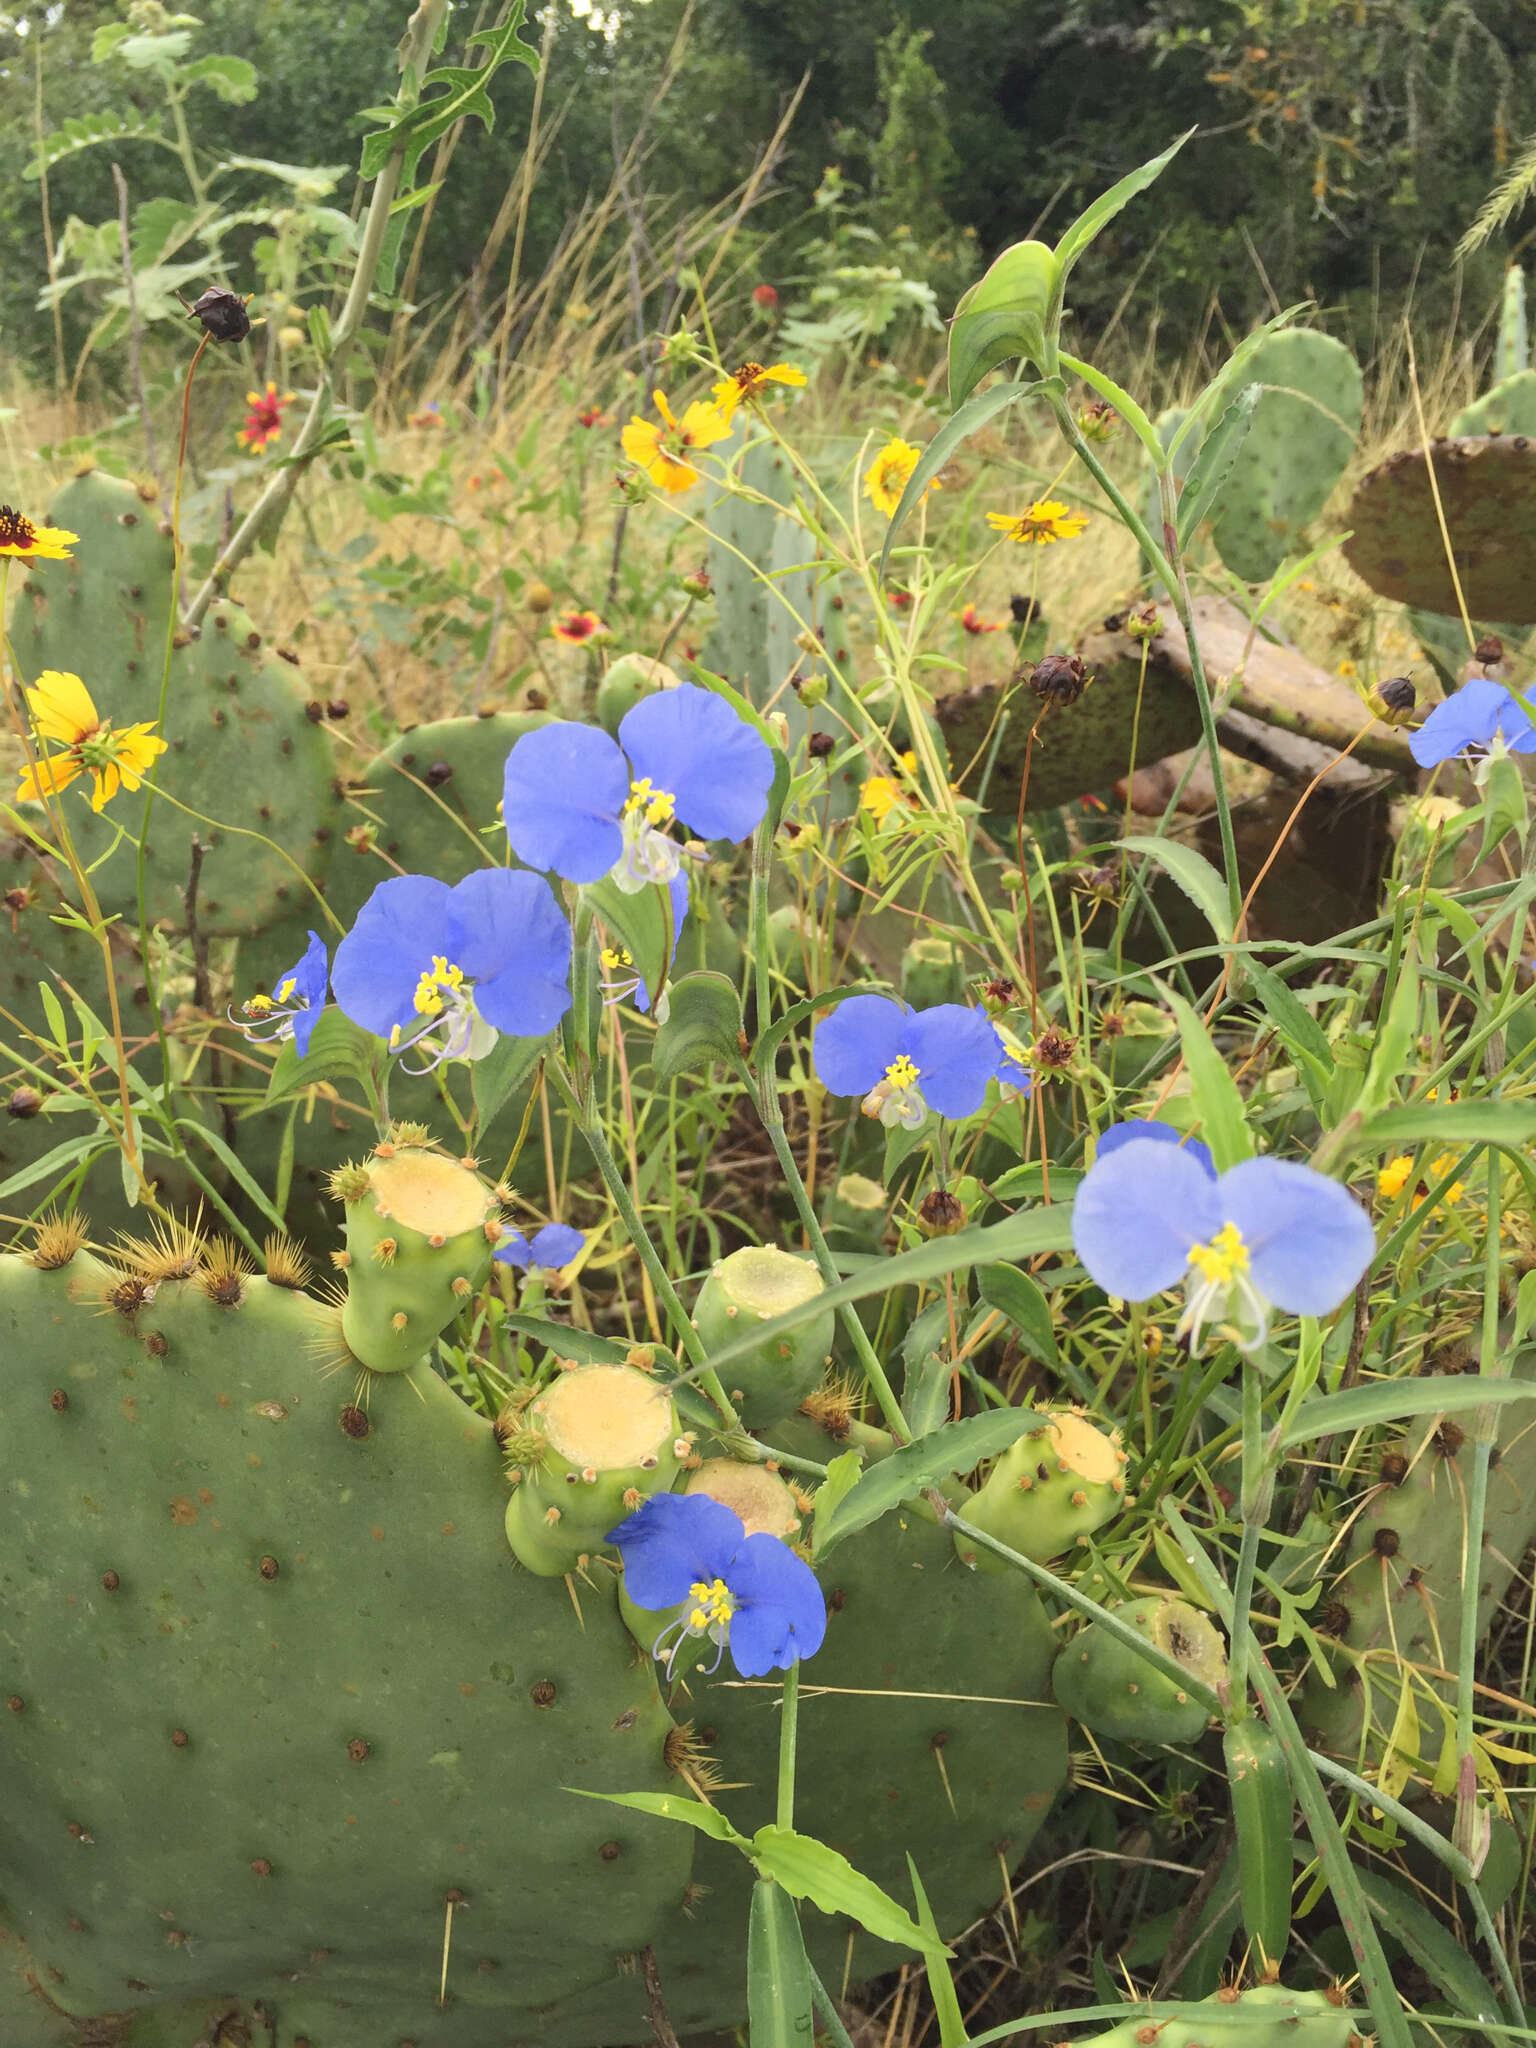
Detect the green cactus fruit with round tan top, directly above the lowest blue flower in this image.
<box><xmin>498</xmin><ymin>1366</ymin><xmax>692</xmax><ymax>1577</ymax></box>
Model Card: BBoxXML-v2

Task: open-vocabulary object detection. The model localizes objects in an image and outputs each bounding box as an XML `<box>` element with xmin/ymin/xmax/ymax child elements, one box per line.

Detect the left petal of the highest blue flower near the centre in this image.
<box><xmin>502</xmin><ymin>723</ymin><xmax>629</xmax><ymax>883</ymax></box>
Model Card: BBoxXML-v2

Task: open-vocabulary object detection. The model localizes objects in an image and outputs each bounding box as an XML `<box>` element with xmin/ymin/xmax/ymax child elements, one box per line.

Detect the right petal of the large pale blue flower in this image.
<box><xmin>1217</xmin><ymin>1159</ymin><xmax>1376</xmax><ymax>1315</ymax></box>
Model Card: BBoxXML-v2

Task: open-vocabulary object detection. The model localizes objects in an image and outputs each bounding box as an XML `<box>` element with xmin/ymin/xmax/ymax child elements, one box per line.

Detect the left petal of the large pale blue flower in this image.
<box><xmin>1071</xmin><ymin>1139</ymin><xmax>1221</xmax><ymax>1300</ymax></box>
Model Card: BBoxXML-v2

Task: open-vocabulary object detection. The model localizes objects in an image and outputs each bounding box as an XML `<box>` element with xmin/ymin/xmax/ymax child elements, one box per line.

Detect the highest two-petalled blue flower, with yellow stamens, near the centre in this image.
<box><xmin>502</xmin><ymin>682</ymin><xmax>774</xmax><ymax>893</ymax></box>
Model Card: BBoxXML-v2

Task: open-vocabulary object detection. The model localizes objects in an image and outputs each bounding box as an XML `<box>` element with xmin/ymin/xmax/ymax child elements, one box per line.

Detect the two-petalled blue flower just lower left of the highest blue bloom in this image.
<box><xmin>332</xmin><ymin>868</ymin><xmax>571</xmax><ymax>1067</ymax></box>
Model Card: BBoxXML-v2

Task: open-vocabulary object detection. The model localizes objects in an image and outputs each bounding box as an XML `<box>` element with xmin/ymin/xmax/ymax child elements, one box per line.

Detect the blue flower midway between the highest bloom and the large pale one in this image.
<box><xmin>813</xmin><ymin>995</ymin><xmax>1028</xmax><ymax>1130</ymax></box>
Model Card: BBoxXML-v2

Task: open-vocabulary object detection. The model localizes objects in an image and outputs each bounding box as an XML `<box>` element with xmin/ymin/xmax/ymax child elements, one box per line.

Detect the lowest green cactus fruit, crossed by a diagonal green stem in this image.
<box><xmin>1051</xmin><ymin>1595</ymin><xmax>1227</xmax><ymax>1743</ymax></box>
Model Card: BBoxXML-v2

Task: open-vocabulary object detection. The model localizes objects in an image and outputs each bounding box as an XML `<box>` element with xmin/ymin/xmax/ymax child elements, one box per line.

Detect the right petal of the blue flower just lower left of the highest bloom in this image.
<box><xmin>449</xmin><ymin>868</ymin><xmax>571</xmax><ymax>1038</ymax></box>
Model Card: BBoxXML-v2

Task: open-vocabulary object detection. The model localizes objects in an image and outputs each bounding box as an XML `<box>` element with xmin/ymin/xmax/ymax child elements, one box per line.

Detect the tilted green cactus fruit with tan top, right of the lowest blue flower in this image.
<box><xmin>954</xmin><ymin>1409</ymin><xmax>1126</xmax><ymax>1571</ymax></box>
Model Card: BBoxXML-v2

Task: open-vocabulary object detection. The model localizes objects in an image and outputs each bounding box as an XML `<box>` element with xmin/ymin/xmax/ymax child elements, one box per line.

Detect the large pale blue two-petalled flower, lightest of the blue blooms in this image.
<box><xmin>1071</xmin><ymin>1137</ymin><xmax>1376</xmax><ymax>1350</ymax></box>
